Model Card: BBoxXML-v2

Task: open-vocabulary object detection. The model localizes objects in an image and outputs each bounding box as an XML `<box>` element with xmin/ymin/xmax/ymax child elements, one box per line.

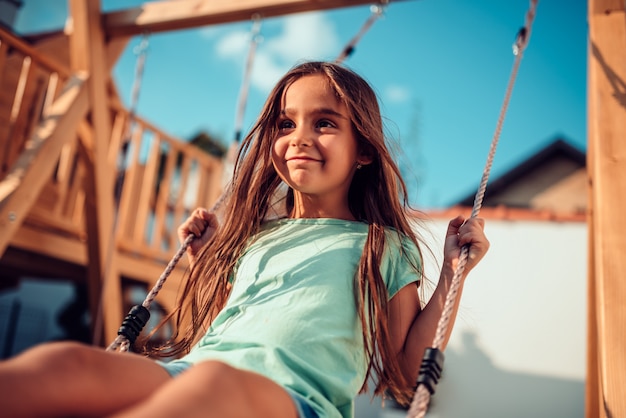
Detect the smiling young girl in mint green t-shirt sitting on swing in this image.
<box><xmin>0</xmin><ymin>62</ymin><xmax>489</xmax><ymax>418</ymax></box>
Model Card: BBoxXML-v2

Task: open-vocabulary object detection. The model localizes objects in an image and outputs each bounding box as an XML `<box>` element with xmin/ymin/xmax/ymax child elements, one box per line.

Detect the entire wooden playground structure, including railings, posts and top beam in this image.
<box><xmin>0</xmin><ymin>0</ymin><xmax>626</xmax><ymax>417</ymax></box>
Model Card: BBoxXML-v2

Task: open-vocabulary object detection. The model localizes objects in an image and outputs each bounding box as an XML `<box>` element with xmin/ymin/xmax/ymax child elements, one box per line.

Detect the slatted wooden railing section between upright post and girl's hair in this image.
<box><xmin>110</xmin><ymin>105</ymin><xmax>222</xmax><ymax>260</ymax></box>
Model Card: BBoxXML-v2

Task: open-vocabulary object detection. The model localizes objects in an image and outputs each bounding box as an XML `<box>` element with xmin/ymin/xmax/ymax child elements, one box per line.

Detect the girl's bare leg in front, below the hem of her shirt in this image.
<box><xmin>115</xmin><ymin>361</ymin><xmax>297</xmax><ymax>418</ymax></box>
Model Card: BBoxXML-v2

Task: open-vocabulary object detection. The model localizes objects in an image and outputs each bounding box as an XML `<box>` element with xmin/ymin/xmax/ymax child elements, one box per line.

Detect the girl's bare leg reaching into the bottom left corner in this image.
<box><xmin>0</xmin><ymin>342</ymin><xmax>172</xmax><ymax>418</ymax></box>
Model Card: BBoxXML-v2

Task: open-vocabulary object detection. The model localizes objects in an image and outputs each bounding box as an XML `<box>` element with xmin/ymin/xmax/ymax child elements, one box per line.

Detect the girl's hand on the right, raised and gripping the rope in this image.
<box><xmin>443</xmin><ymin>216</ymin><xmax>489</xmax><ymax>275</ymax></box>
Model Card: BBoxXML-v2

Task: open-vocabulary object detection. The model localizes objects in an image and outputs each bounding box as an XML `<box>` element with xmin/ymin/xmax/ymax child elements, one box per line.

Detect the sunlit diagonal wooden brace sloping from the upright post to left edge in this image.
<box><xmin>0</xmin><ymin>76</ymin><xmax>88</xmax><ymax>255</ymax></box>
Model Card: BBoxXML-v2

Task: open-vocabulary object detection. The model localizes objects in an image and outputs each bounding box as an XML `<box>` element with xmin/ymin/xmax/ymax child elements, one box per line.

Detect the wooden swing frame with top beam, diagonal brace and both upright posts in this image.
<box><xmin>0</xmin><ymin>0</ymin><xmax>626</xmax><ymax>418</ymax></box>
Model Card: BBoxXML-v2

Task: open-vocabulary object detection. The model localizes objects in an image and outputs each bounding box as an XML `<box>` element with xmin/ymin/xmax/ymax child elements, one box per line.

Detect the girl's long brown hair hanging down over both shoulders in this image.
<box><xmin>145</xmin><ymin>62</ymin><xmax>422</xmax><ymax>403</ymax></box>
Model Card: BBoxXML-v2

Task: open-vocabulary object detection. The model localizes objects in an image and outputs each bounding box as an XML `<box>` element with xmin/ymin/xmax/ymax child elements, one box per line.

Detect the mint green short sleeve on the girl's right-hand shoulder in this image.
<box><xmin>381</xmin><ymin>232</ymin><xmax>422</xmax><ymax>299</ymax></box>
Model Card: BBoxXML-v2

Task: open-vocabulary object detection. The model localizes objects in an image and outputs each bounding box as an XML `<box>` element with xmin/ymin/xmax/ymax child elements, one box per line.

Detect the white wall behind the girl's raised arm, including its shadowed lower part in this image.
<box><xmin>356</xmin><ymin>220</ymin><xmax>587</xmax><ymax>418</ymax></box>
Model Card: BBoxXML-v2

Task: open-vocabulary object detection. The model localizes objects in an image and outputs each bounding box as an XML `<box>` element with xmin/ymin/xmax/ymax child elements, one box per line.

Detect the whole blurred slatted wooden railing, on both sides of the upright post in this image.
<box><xmin>0</xmin><ymin>28</ymin><xmax>223</xmax><ymax>282</ymax></box>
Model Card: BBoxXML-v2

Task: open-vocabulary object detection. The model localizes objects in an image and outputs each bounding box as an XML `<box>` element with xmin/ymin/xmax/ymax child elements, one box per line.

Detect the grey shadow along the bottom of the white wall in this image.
<box><xmin>356</xmin><ymin>332</ymin><xmax>585</xmax><ymax>418</ymax></box>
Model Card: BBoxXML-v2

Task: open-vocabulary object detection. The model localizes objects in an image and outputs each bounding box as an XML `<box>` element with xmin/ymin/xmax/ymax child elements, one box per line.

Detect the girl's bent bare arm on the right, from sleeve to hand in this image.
<box><xmin>389</xmin><ymin>216</ymin><xmax>489</xmax><ymax>382</ymax></box>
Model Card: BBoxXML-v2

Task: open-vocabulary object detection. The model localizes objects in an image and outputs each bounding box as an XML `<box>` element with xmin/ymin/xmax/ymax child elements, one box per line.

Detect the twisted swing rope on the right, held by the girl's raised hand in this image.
<box><xmin>407</xmin><ymin>0</ymin><xmax>538</xmax><ymax>418</ymax></box>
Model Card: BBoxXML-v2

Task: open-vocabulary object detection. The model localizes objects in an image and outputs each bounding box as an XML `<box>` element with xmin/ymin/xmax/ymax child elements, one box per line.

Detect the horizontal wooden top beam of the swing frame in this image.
<box><xmin>104</xmin><ymin>0</ymin><xmax>399</xmax><ymax>37</ymax></box>
